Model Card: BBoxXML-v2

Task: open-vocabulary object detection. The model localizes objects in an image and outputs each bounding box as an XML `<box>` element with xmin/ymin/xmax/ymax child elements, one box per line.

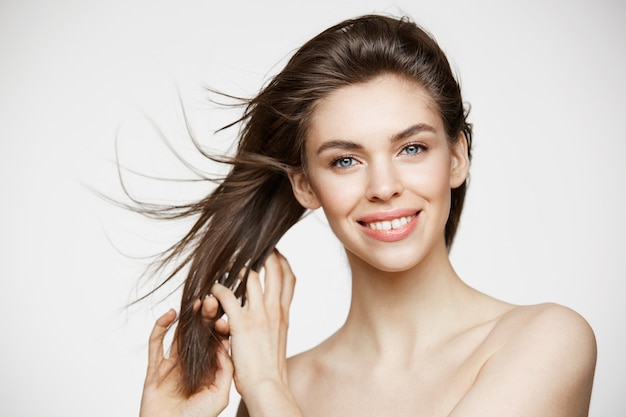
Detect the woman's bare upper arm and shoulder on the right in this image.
<box><xmin>450</xmin><ymin>305</ymin><xmax>596</xmax><ymax>417</ymax></box>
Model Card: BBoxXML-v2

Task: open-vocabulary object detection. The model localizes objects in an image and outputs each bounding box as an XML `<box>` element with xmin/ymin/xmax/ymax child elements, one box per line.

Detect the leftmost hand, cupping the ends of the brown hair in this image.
<box><xmin>139</xmin><ymin>306</ymin><xmax>233</xmax><ymax>417</ymax></box>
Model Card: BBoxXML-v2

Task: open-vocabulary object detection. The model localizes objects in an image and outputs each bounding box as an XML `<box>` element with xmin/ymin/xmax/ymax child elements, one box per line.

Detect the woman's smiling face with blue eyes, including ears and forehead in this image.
<box><xmin>291</xmin><ymin>75</ymin><xmax>469</xmax><ymax>272</ymax></box>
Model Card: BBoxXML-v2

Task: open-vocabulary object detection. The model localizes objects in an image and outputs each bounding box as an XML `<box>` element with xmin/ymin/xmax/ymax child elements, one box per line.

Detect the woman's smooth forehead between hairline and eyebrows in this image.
<box><xmin>307</xmin><ymin>75</ymin><xmax>443</xmax><ymax>142</ymax></box>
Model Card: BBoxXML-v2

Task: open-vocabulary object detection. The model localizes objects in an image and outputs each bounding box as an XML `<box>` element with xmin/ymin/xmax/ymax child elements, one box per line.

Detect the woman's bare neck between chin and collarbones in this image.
<box><xmin>338</xmin><ymin>240</ymin><xmax>474</xmax><ymax>360</ymax></box>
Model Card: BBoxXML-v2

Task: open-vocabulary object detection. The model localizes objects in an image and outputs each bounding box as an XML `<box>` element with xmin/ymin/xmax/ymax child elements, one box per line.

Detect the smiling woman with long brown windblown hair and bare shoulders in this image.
<box><xmin>136</xmin><ymin>16</ymin><xmax>596</xmax><ymax>417</ymax></box>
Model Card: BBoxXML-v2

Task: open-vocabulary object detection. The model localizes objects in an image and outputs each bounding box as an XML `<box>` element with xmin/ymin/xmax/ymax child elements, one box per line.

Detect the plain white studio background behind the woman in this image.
<box><xmin>0</xmin><ymin>0</ymin><xmax>626</xmax><ymax>417</ymax></box>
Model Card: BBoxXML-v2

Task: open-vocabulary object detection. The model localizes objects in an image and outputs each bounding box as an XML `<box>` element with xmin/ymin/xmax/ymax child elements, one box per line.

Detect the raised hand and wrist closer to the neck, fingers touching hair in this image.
<box><xmin>211</xmin><ymin>251</ymin><xmax>302</xmax><ymax>417</ymax></box>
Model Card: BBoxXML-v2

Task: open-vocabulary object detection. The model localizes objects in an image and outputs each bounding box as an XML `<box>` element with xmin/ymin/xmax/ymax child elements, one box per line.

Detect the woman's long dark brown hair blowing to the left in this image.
<box><xmin>138</xmin><ymin>15</ymin><xmax>472</xmax><ymax>395</ymax></box>
